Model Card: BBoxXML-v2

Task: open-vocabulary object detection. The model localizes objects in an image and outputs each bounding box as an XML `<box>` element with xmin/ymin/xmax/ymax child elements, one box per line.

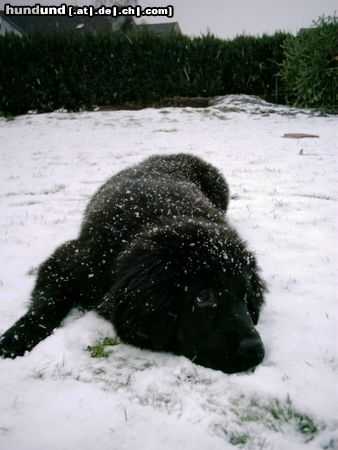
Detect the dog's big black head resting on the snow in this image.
<box><xmin>99</xmin><ymin>220</ymin><xmax>265</xmax><ymax>373</ymax></box>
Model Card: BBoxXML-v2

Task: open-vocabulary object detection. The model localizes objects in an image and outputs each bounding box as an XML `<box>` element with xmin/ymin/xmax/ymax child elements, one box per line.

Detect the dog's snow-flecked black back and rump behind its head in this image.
<box><xmin>80</xmin><ymin>153</ymin><xmax>229</xmax><ymax>242</ymax></box>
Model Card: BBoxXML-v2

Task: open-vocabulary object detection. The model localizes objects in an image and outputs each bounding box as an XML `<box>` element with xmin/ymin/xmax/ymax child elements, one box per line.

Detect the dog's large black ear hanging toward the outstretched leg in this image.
<box><xmin>98</xmin><ymin>242</ymin><xmax>178</xmax><ymax>350</ymax></box>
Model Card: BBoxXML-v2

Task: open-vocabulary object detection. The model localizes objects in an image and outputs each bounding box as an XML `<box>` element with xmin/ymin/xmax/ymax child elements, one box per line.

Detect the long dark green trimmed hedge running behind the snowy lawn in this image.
<box><xmin>0</xmin><ymin>31</ymin><xmax>288</xmax><ymax>115</ymax></box>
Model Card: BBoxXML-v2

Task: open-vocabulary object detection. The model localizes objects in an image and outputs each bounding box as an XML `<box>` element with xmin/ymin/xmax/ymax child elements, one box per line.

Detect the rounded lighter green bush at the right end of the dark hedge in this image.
<box><xmin>280</xmin><ymin>16</ymin><xmax>338</xmax><ymax>111</ymax></box>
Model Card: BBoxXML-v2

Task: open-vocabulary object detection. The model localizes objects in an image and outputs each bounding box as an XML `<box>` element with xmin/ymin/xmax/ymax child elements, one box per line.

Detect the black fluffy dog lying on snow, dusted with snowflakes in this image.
<box><xmin>0</xmin><ymin>154</ymin><xmax>265</xmax><ymax>373</ymax></box>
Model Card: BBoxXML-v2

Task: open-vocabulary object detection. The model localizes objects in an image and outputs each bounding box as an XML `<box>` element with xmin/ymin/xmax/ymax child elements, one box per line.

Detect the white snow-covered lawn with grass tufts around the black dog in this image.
<box><xmin>0</xmin><ymin>97</ymin><xmax>338</xmax><ymax>450</ymax></box>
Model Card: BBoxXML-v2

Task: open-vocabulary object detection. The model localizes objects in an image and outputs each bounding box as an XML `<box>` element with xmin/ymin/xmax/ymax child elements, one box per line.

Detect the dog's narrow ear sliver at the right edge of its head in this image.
<box><xmin>245</xmin><ymin>252</ymin><xmax>267</xmax><ymax>325</ymax></box>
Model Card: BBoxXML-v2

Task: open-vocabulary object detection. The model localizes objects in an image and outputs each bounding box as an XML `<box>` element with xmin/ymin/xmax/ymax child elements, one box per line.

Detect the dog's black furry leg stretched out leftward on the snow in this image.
<box><xmin>0</xmin><ymin>241</ymin><xmax>78</xmax><ymax>358</ymax></box>
